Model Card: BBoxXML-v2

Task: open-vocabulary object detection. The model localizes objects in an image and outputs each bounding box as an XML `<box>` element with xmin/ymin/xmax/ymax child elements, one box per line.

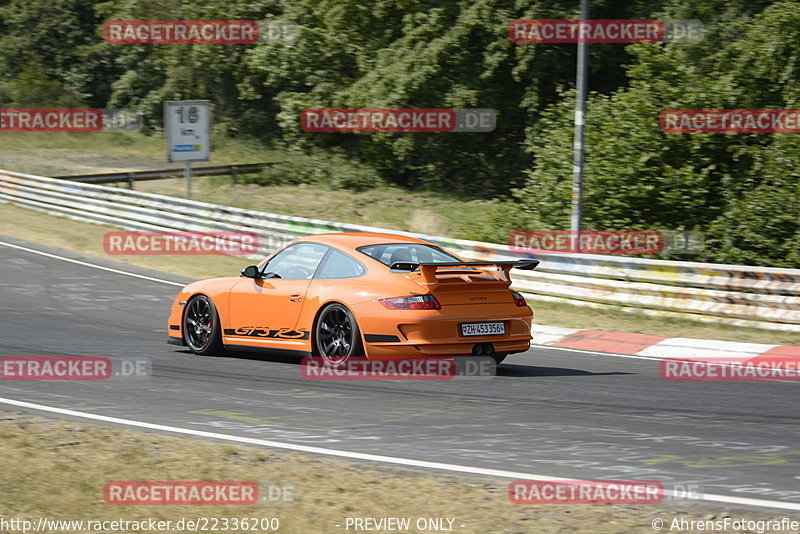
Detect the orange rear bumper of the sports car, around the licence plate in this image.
<box><xmin>353</xmin><ymin>302</ymin><xmax>533</xmax><ymax>359</ymax></box>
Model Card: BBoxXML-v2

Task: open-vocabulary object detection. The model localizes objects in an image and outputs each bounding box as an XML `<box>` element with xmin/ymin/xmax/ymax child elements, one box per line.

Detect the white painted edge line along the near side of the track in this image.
<box><xmin>0</xmin><ymin>397</ymin><xmax>800</xmax><ymax>511</ymax></box>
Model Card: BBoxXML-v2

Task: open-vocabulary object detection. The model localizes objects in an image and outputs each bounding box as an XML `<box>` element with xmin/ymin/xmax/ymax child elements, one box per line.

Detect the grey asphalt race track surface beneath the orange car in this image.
<box><xmin>0</xmin><ymin>235</ymin><xmax>800</xmax><ymax>509</ymax></box>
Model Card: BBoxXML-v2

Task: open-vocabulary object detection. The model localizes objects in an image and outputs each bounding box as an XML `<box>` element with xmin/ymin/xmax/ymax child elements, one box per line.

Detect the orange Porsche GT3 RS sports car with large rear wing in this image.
<box><xmin>168</xmin><ymin>233</ymin><xmax>539</xmax><ymax>365</ymax></box>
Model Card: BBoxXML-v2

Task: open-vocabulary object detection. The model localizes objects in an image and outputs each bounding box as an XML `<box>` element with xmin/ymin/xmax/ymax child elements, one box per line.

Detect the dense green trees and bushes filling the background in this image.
<box><xmin>0</xmin><ymin>0</ymin><xmax>800</xmax><ymax>267</ymax></box>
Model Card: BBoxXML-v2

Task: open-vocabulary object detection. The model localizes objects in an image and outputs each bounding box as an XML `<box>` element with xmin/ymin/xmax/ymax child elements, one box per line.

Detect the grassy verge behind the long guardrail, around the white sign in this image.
<box><xmin>0</xmin><ymin>132</ymin><xmax>496</xmax><ymax>239</ymax></box>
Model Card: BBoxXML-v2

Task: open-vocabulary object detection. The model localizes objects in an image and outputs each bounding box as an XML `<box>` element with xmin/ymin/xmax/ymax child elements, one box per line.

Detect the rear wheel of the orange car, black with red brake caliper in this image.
<box><xmin>313</xmin><ymin>304</ymin><xmax>363</xmax><ymax>367</ymax></box>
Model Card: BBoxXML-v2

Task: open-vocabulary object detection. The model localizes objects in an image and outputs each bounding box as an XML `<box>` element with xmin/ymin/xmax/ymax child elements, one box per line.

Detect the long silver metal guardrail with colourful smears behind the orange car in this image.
<box><xmin>0</xmin><ymin>170</ymin><xmax>800</xmax><ymax>331</ymax></box>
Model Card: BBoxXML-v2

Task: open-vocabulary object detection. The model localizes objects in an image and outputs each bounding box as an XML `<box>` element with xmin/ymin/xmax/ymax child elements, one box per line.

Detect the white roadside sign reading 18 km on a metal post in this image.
<box><xmin>164</xmin><ymin>100</ymin><xmax>211</xmax><ymax>198</ymax></box>
